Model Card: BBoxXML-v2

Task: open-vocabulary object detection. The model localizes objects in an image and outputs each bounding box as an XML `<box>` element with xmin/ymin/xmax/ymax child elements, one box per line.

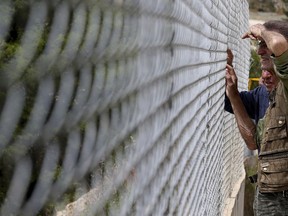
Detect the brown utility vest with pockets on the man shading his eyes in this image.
<box><xmin>257</xmin><ymin>82</ymin><xmax>288</xmax><ymax>193</ymax></box>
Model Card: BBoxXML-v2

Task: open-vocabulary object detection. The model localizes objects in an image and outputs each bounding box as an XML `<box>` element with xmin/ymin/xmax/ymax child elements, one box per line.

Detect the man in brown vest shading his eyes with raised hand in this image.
<box><xmin>226</xmin><ymin>21</ymin><xmax>288</xmax><ymax>216</ymax></box>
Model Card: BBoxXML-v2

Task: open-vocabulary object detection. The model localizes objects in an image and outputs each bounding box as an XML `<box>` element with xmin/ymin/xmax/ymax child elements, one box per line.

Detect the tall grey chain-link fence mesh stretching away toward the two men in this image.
<box><xmin>0</xmin><ymin>0</ymin><xmax>250</xmax><ymax>216</ymax></box>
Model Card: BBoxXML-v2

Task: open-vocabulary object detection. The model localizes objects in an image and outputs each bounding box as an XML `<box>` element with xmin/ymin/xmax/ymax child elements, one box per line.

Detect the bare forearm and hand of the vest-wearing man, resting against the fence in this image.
<box><xmin>225</xmin><ymin>64</ymin><xmax>257</xmax><ymax>150</ymax></box>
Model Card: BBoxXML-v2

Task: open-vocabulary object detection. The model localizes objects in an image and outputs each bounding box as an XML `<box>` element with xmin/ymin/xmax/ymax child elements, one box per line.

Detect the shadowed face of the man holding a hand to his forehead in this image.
<box><xmin>257</xmin><ymin>41</ymin><xmax>274</xmax><ymax>71</ymax></box>
